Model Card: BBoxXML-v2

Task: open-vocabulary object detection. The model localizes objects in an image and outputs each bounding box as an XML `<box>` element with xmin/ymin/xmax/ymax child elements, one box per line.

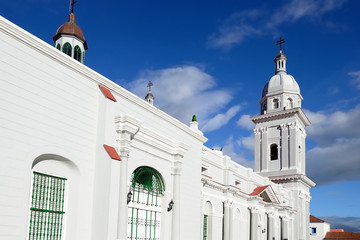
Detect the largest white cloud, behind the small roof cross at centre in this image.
<box><xmin>129</xmin><ymin>66</ymin><xmax>232</xmax><ymax>124</ymax></box>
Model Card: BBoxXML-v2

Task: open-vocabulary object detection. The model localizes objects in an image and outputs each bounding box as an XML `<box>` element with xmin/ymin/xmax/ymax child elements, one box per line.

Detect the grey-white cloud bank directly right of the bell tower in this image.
<box><xmin>306</xmin><ymin>105</ymin><xmax>360</xmax><ymax>185</ymax></box>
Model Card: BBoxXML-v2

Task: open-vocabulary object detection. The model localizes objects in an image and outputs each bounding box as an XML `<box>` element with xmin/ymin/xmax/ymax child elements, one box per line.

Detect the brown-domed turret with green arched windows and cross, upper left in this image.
<box><xmin>53</xmin><ymin>0</ymin><xmax>88</xmax><ymax>63</ymax></box>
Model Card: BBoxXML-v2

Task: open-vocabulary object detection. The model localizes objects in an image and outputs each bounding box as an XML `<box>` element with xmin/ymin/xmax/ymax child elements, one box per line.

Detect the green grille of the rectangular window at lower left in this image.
<box><xmin>29</xmin><ymin>172</ymin><xmax>66</xmax><ymax>240</ymax></box>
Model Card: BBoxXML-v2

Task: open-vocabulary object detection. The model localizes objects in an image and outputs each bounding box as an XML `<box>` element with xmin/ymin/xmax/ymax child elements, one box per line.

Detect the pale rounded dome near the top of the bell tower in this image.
<box><xmin>262</xmin><ymin>73</ymin><xmax>300</xmax><ymax>97</ymax></box>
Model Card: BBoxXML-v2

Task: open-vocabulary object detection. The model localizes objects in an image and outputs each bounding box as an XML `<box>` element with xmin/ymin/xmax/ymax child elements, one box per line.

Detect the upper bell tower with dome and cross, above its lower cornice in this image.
<box><xmin>251</xmin><ymin>38</ymin><xmax>310</xmax><ymax>177</ymax></box>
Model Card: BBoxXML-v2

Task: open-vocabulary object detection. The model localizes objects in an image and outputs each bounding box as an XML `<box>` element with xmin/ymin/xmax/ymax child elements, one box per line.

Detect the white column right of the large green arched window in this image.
<box><xmin>171</xmin><ymin>155</ymin><xmax>182</xmax><ymax>240</ymax></box>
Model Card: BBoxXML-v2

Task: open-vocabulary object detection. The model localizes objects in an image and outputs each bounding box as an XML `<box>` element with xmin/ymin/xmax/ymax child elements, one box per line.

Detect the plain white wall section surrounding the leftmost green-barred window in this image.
<box><xmin>0</xmin><ymin>19</ymin><xmax>99</xmax><ymax>239</ymax></box>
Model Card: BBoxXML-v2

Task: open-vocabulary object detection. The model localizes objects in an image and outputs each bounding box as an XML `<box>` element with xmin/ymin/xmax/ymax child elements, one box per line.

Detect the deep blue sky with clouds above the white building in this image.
<box><xmin>0</xmin><ymin>0</ymin><xmax>360</xmax><ymax>231</ymax></box>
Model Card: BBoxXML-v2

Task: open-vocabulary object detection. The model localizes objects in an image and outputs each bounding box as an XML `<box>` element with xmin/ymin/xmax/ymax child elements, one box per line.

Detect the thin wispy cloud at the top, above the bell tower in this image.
<box><xmin>209</xmin><ymin>0</ymin><xmax>345</xmax><ymax>49</ymax></box>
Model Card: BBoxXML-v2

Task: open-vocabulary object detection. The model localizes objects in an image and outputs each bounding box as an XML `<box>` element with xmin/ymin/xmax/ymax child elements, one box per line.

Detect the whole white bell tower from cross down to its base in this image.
<box><xmin>251</xmin><ymin>38</ymin><xmax>315</xmax><ymax>239</ymax></box>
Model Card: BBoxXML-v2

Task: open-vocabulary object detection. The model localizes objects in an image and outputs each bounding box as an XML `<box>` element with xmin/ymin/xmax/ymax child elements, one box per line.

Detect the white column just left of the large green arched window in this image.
<box><xmin>117</xmin><ymin>132</ymin><xmax>131</xmax><ymax>240</ymax></box>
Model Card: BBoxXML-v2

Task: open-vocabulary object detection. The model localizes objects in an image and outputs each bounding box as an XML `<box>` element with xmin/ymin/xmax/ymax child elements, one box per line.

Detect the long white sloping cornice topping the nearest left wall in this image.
<box><xmin>0</xmin><ymin>16</ymin><xmax>207</xmax><ymax>143</ymax></box>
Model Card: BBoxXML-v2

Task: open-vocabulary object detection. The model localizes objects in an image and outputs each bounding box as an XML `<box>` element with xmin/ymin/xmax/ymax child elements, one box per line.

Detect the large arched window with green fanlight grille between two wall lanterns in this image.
<box><xmin>127</xmin><ymin>167</ymin><xmax>165</xmax><ymax>240</ymax></box>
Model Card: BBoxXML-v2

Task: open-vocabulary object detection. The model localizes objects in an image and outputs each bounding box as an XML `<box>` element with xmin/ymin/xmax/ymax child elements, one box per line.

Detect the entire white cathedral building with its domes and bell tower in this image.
<box><xmin>0</xmin><ymin>7</ymin><xmax>315</xmax><ymax>240</ymax></box>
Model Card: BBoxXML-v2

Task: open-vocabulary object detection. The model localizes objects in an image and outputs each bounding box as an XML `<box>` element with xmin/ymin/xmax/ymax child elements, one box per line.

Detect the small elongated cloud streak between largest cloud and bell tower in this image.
<box><xmin>201</xmin><ymin>105</ymin><xmax>241</xmax><ymax>132</ymax></box>
